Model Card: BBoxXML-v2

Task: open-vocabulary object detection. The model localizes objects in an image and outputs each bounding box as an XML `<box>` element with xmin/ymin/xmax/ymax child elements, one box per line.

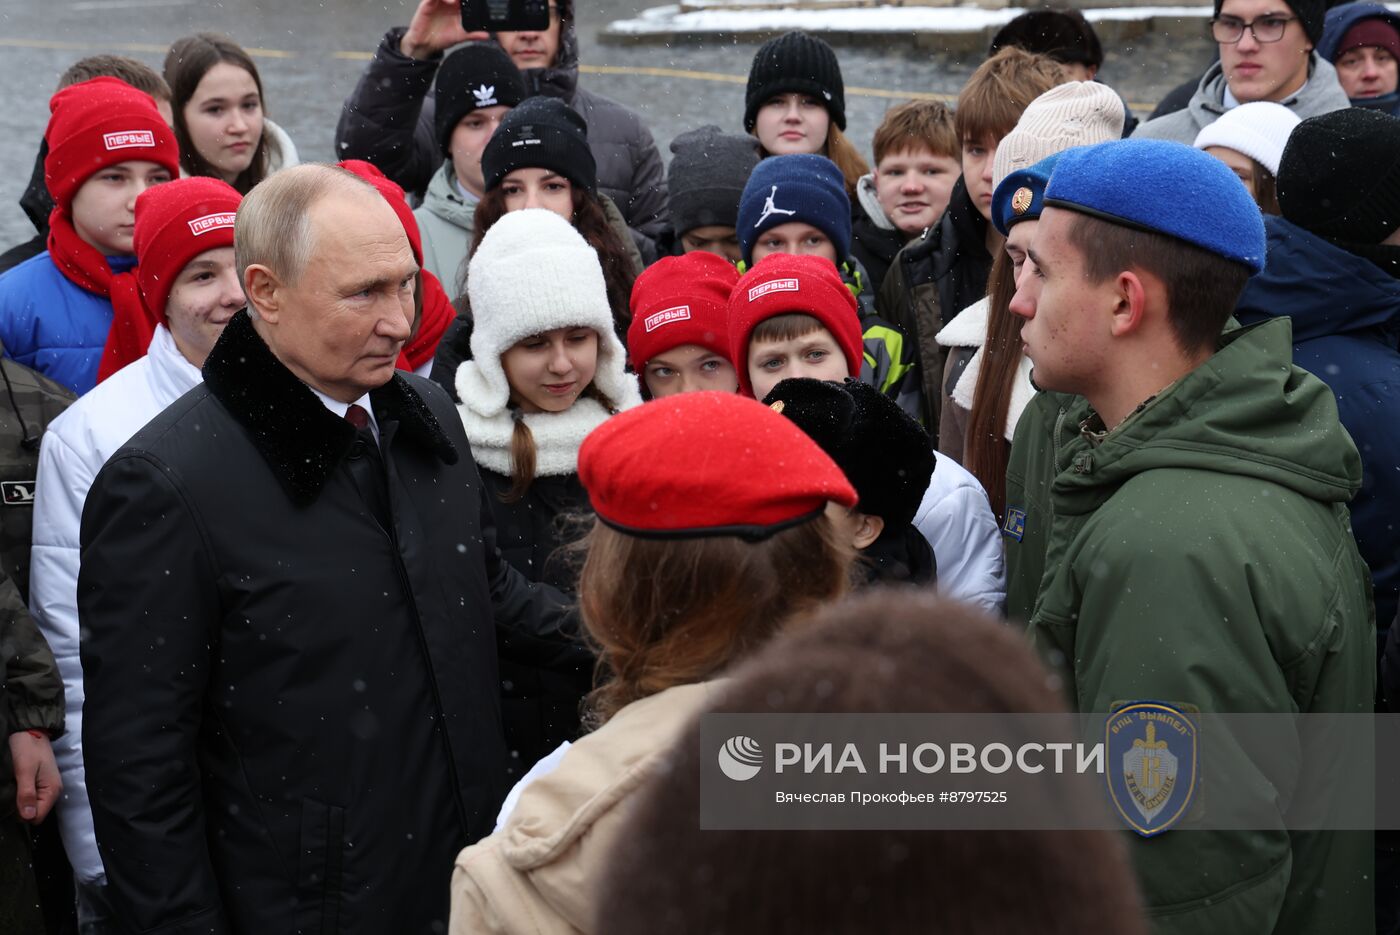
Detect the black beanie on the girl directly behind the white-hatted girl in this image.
<box><xmin>482</xmin><ymin>98</ymin><xmax>598</xmax><ymax>193</ymax></box>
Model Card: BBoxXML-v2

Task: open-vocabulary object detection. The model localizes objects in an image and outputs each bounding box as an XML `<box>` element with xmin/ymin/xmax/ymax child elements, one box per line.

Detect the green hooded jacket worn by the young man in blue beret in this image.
<box><xmin>1008</xmin><ymin>319</ymin><xmax>1375</xmax><ymax>935</ymax></box>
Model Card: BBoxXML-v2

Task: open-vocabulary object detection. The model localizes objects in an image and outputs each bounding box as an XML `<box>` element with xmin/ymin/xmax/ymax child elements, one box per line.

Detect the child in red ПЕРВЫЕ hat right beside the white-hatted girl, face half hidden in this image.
<box><xmin>627</xmin><ymin>251</ymin><xmax>739</xmax><ymax>399</ymax></box>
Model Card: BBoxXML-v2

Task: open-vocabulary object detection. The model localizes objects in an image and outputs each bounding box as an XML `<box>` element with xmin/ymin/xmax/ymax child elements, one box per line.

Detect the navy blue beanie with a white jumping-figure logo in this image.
<box><xmin>736</xmin><ymin>154</ymin><xmax>851</xmax><ymax>266</ymax></box>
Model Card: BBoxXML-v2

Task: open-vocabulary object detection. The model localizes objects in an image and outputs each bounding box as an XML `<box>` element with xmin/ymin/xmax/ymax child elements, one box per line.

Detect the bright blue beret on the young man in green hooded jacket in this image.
<box><xmin>1044</xmin><ymin>140</ymin><xmax>1264</xmax><ymax>273</ymax></box>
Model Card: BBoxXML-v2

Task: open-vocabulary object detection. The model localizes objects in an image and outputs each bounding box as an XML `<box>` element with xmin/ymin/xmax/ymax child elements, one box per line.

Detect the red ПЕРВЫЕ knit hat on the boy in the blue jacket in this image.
<box><xmin>43</xmin><ymin>77</ymin><xmax>179</xmax><ymax>211</ymax></box>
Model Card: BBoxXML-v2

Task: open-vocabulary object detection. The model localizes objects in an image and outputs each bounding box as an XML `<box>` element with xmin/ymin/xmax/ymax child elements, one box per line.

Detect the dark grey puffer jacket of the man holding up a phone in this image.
<box><xmin>336</xmin><ymin>20</ymin><xmax>671</xmax><ymax>256</ymax></box>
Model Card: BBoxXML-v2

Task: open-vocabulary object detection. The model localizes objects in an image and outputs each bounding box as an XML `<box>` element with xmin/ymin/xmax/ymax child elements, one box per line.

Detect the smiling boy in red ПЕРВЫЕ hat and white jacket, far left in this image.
<box><xmin>29</xmin><ymin>178</ymin><xmax>245</xmax><ymax>920</ymax></box>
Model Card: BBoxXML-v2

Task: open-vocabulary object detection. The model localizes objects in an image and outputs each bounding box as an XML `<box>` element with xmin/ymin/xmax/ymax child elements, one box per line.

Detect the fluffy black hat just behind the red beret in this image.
<box><xmin>763</xmin><ymin>378</ymin><xmax>934</xmax><ymax>529</ymax></box>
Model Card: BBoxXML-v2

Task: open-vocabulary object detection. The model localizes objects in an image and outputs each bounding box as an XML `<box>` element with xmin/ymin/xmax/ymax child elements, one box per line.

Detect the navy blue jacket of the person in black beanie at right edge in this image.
<box><xmin>1235</xmin><ymin>214</ymin><xmax>1400</xmax><ymax>638</ymax></box>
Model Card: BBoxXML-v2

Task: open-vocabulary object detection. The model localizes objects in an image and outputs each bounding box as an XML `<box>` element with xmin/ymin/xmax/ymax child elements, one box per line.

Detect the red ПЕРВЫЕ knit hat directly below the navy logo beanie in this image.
<box><xmin>729</xmin><ymin>253</ymin><xmax>865</xmax><ymax>396</ymax></box>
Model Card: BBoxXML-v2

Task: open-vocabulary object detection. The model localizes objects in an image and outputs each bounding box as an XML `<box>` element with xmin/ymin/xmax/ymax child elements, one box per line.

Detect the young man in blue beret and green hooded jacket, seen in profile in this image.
<box><xmin>1007</xmin><ymin>140</ymin><xmax>1375</xmax><ymax>935</ymax></box>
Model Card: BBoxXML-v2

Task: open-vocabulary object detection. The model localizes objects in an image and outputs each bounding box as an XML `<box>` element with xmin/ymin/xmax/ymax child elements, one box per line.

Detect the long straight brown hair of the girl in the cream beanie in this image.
<box><xmin>963</xmin><ymin>244</ymin><xmax>1021</xmax><ymax>522</ymax></box>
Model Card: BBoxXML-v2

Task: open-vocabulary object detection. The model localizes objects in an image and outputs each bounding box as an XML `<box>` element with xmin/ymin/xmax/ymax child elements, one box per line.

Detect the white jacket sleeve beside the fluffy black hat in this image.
<box><xmin>914</xmin><ymin>458</ymin><xmax>1007</xmax><ymax>614</ymax></box>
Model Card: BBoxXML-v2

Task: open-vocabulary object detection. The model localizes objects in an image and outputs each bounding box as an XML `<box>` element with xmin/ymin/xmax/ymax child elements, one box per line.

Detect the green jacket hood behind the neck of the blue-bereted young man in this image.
<box><xmin>1053</xmin><ymin>319</ymin><xmax>1361</xmax><ymax>515</ymax></box>
